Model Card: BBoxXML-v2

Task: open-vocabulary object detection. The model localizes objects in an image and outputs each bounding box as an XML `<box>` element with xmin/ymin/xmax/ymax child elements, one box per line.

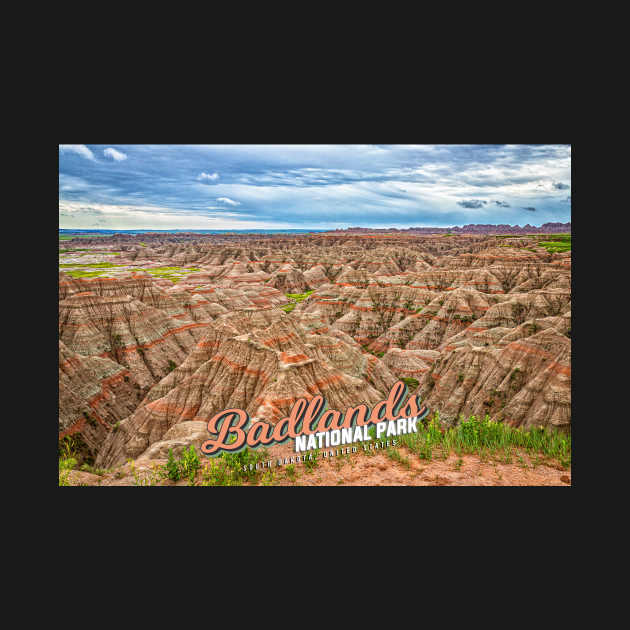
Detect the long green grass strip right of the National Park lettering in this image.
<box><xmin>400</xmin><ymin>412</ymin><xmax>571</xmax><ymax>468</ymax></box>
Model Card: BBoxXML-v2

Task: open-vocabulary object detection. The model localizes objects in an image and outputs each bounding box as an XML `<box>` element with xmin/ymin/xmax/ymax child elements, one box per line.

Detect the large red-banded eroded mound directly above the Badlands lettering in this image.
<box><xmin>98</xmin><ymin>313</ymin><xmax>396</xmax><ymax>466</ymax></box>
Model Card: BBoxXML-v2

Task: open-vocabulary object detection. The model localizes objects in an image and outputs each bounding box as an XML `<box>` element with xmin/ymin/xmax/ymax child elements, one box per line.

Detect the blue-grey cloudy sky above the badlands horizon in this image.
<box><xmin>59</xmin><ymin>144</ymin><xmax>571</xmax><ymax>230</ymax></box>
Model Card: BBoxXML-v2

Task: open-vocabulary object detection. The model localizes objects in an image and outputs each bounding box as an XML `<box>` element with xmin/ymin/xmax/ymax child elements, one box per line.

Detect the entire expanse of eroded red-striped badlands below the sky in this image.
<box><xmin>59</xmin><ymin>232</ymin><xmax>571</xmax><ymax>484</ymax></box>
